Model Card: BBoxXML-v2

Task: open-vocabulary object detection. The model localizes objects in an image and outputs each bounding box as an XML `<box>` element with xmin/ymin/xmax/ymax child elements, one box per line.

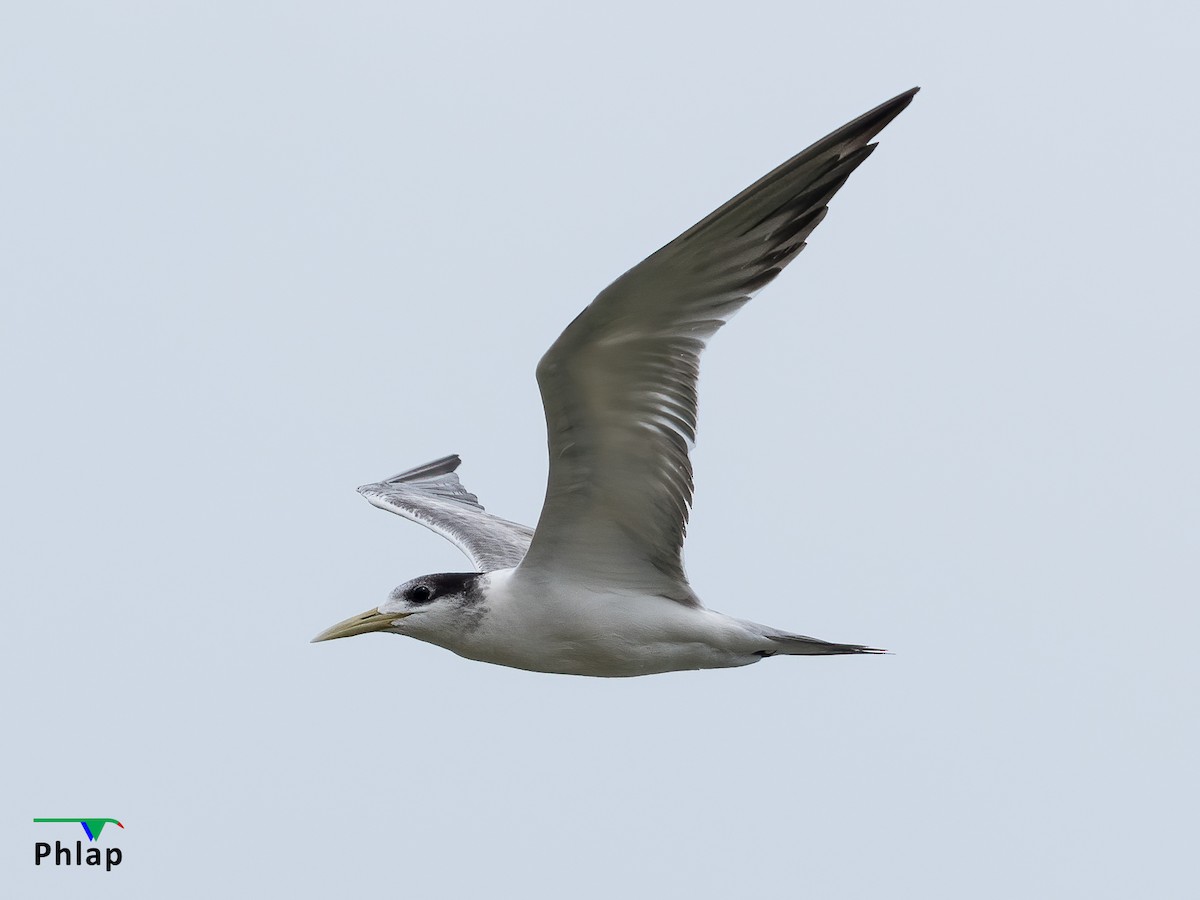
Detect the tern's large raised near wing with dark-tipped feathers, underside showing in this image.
<box><xmin>521</xmin><ymin>88</ymin><xmax>917</xmax><ymax>592</ymax></box>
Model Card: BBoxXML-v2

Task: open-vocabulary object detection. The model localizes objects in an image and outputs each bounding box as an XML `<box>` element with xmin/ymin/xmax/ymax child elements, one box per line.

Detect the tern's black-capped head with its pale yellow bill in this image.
<box><xmin>312</xmin><ymin>572</ymin><xmax>484</xmax><ymax>644</ymax></box>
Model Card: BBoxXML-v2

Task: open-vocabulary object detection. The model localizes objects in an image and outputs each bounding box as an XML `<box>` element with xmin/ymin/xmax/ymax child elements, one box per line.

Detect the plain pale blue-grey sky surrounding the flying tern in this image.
<box><xmin>0</xmin><ymin>1</ymin><xmax>1200</xmax><ymax>900</ymax></box>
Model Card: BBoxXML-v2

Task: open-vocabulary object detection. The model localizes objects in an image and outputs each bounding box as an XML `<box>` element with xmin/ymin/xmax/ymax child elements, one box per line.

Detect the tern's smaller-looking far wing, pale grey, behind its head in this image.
<box><xmin>359</xmin><ymin>455</ymin><xmax>533</xmax><ymax>572</ymax></box>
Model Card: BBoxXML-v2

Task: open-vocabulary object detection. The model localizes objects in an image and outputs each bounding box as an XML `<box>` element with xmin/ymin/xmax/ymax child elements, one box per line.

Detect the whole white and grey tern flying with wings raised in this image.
<box><xmin>313</xmin><ymin>88</ymin><xmax>918</xmax><ymax>677</ymax></box>
